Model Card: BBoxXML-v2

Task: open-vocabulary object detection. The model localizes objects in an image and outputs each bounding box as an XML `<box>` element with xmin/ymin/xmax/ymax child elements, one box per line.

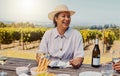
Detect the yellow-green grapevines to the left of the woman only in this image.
<box><xmin>0</xmin><ymin>28</ymin><xmax>46</xmax><ymax>50</ymax></box>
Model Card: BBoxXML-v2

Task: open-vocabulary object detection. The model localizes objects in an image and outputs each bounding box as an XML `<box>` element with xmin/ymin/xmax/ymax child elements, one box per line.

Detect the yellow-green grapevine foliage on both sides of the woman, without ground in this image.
<box><xmin>0</xmin><ymin>27</ymin><xmax>116</xmax><ymax>49</ymax></box>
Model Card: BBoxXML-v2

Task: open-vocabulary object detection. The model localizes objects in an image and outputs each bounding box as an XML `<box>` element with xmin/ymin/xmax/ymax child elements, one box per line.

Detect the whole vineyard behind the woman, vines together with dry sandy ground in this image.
<box><xmin>0</xmin><ymin>27</ymin><xmax>120</xmax><ymax>64</ymax></box>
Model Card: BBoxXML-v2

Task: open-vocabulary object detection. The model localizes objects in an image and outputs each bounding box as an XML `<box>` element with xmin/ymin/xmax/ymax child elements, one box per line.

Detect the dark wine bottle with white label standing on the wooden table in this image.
<box><xmin>91</xmin><ymin>35</ymin><xmax>100</xmax><ymax>67</ymax></box>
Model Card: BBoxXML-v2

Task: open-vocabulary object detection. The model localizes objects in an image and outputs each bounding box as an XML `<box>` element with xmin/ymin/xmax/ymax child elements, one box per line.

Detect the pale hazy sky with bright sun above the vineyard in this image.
<box><xmin>0</xmin><ymin>0</ymin><xmax>120</xmax><ymax>25</ymax></box>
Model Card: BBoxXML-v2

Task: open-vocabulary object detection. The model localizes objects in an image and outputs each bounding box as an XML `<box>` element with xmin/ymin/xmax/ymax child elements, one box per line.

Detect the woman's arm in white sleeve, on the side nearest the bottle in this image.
<box><xmin>70</xmin><ymin>31</ymin><xmax>84</xmax><ymax>68</ymax></box>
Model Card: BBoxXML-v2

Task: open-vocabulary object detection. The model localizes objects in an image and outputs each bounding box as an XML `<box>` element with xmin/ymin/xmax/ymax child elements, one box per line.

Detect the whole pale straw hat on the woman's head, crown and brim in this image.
<box><xmin>48</xmin><ymin>4</ymin><xmax>75</xmax><ymax>20</ymax></box>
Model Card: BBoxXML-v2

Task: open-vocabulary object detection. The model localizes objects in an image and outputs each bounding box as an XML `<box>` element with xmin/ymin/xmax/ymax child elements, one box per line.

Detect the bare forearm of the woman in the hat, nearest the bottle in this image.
<box><xmin>70</xmin><ymin>57</ymin><xmax>84</xmax><ymax>68</ymax></box>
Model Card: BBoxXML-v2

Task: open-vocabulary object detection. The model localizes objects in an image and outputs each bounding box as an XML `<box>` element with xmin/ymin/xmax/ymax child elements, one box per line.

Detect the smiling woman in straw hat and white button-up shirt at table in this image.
<box><xmin>36</xmin><ymin>5</ymin><xmax>84</xmax><ymax>68</ymax></box>
